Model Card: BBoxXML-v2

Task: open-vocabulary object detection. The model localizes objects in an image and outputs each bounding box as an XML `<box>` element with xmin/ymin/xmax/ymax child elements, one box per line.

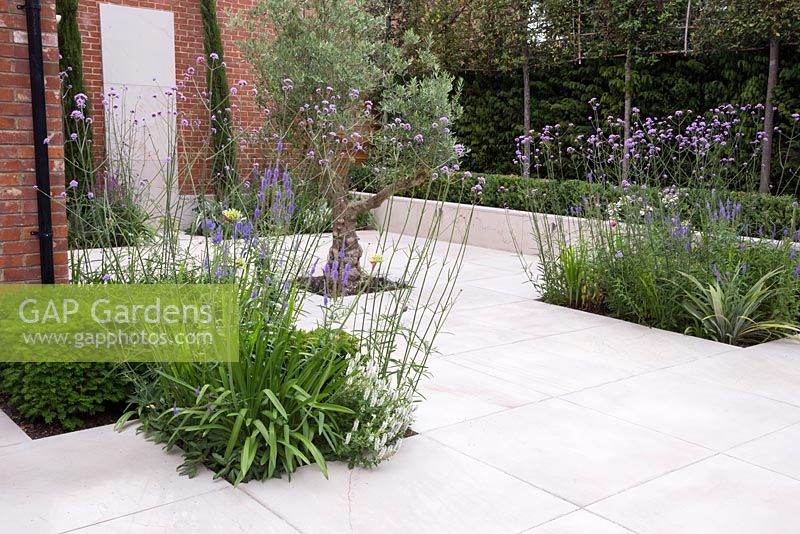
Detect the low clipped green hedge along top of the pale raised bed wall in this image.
<box><xmin>353</xmin><ymin>168</ymin><xmax>800</xmax><ymax>238</ymax></box>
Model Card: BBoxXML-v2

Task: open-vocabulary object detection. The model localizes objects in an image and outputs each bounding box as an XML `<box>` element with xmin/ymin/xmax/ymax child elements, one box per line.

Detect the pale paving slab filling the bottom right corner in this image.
<box><xmin>590</xmin><ymin>456</ymin><xmax>800</xmax><ymax>534</ymax></box>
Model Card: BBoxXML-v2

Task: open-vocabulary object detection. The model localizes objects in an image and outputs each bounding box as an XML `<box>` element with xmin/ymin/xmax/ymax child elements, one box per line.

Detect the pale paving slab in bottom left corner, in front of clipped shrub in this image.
<box><xmin>0</xmin><ymin>426</ymin><xmax>228</xmax><ymax>533</ymax></box>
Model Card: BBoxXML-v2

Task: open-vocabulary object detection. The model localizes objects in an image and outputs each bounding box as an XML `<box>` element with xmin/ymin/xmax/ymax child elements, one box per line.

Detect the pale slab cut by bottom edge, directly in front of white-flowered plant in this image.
<box><xmin>243</xmin><ymin>436</ymin><xmax>575</xmax><ymax>534</ymax></box>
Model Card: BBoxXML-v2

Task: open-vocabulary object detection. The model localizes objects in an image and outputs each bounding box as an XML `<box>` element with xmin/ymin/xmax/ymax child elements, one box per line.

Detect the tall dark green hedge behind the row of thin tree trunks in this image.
<box><xmin>453</xmin><ymin>45</ymin><xmax>800</xmax><ymax>191</ymax></box>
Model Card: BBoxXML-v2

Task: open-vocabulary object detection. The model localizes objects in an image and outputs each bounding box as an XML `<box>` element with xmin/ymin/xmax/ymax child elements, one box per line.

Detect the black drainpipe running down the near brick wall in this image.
<box><xmin>17</xmin><ymin>0</ymin><xmax>55</xmax><ymax>284</ymax></box>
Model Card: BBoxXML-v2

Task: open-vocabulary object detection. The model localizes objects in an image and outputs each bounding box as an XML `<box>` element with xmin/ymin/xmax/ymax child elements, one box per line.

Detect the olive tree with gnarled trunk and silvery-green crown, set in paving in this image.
<box><xmin>239</xmin><ymin>0</ymin><xmax>461</xmax><ymax>291</ymax></box>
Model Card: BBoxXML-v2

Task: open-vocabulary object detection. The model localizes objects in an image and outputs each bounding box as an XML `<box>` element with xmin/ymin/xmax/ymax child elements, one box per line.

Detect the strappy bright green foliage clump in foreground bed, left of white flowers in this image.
<box><xmin>118</xmin><ymin>313</ymin><xmax>356</xmax><ymax>484</ymax></box>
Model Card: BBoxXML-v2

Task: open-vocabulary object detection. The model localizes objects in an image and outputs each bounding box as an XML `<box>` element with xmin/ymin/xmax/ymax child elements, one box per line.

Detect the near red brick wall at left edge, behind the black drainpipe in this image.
<box><xmin>0</xmin><ymin>0</ymin><xmax>67</xmax><ymax>283</ymax></box>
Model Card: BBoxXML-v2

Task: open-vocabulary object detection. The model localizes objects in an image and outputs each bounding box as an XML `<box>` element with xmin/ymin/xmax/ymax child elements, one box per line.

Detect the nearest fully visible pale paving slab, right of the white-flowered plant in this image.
<box><xmin>426</xmin><ymin>399</ymin><xmax>711</xmax><ymax>506</ymax></box>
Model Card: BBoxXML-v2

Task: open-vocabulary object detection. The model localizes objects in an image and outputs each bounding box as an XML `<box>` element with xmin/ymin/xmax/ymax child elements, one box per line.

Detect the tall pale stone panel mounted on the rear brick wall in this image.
<box><xmin>100</xmin><ymin>4</ymin><xmax>178</xmax><ymax>218</ymax></box>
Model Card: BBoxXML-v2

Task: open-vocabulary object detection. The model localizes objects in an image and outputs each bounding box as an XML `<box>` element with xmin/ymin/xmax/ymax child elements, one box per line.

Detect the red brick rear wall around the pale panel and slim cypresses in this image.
<box><xmin>78</xmin><ymin>0</ymin><xmax>258</xmax><ymax>194</ymax></box>
